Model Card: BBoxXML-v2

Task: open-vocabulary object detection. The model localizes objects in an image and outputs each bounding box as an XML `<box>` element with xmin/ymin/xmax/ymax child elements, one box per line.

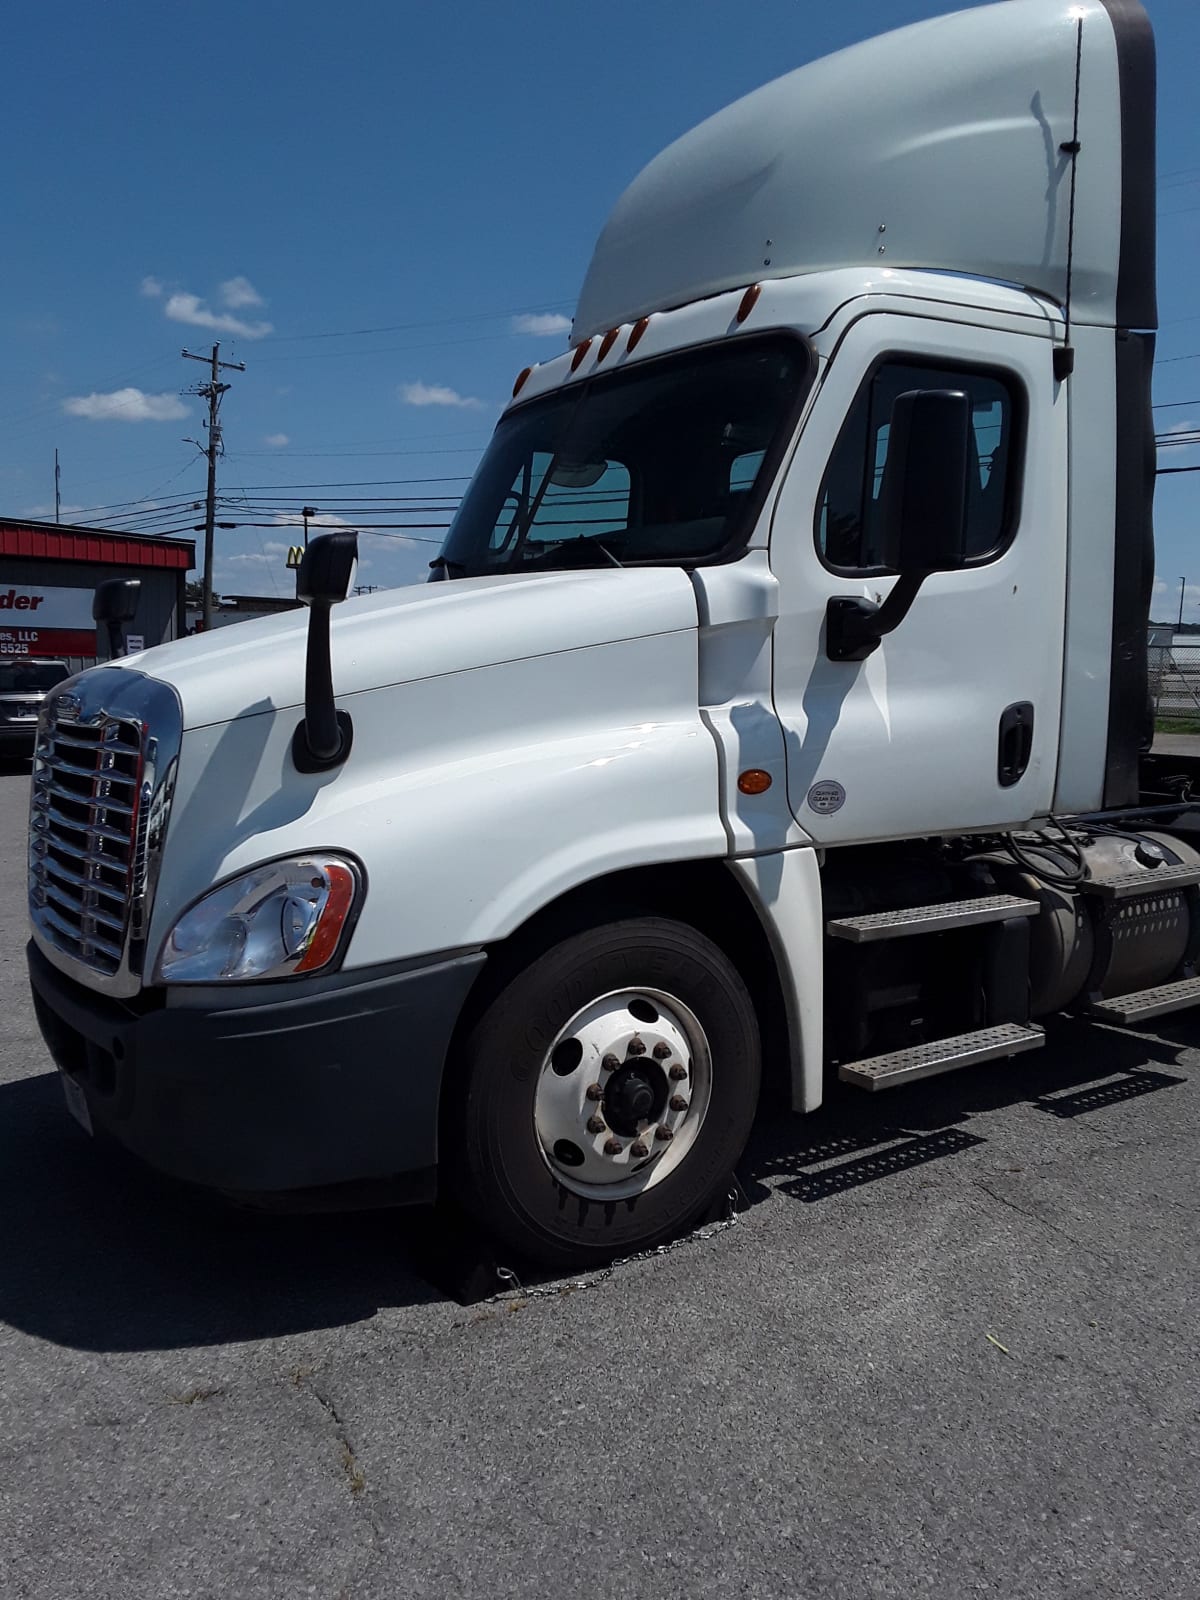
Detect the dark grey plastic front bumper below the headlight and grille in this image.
<box><xmin>27</xmin><ymin>944</ymin><xmax>485</xmax><ymax>1205</ymax></box>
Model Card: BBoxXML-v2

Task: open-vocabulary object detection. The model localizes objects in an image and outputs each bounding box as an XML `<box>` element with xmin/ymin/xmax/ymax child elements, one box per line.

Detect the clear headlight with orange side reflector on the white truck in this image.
<box><xmin>157</xmin><ymin>856</ymin><xmax>360</xmax><ymax>984</ymax></box>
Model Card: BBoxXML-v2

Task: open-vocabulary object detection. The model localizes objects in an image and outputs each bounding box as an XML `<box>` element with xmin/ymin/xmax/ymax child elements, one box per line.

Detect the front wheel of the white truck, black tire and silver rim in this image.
<box><xmin>450</xmin><ymin>917</ymin><xmax>762</xmax><ymax>1269</ymax></box>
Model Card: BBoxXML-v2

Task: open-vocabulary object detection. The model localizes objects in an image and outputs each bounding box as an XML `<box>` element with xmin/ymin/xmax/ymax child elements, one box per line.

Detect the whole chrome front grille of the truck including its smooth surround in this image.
<box><xmin>29</xmin><ymin>667</ymin><xmax>181</xmax><ymax>994</ymax></box>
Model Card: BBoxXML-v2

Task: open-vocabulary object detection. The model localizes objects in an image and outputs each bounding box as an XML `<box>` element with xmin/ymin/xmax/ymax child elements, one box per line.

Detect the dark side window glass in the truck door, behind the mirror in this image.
<box><xmin>816</xmin><ymin>358</ymin><xmax>1024</xmax><ymax>573</ymax></box>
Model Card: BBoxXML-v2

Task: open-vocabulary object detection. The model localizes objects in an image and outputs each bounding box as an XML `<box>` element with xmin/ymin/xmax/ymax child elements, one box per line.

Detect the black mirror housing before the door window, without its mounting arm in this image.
<box><xmin>880</xmin><ymin>389</ymin><xmax>971</xmax><ymax>576</ymax></box>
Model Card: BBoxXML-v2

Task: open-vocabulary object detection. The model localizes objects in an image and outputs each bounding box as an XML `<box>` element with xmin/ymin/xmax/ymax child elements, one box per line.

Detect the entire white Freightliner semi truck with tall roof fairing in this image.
<box><xmin>29</xmin><ymin>0</ymin><xmax>1200</xmax><ymax>1266</ymax></box>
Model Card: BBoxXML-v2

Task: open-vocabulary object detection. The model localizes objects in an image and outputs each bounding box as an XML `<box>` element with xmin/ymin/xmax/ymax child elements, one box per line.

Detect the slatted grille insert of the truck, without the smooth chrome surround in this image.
<box><xmin>29</xmin><ymin>717</ymin><xmax>142</xmax><ymax>973</ymax></box>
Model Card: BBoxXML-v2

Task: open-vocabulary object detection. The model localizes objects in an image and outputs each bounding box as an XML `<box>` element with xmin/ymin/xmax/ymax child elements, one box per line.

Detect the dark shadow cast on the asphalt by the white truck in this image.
<box><xmin>0</xmin><ymin>1027</ymin><xmax>1184</xmax><ymax>1350</ymax></box>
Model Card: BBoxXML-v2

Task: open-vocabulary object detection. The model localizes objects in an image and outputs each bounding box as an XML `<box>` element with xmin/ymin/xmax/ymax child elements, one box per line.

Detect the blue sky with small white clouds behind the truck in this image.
<box><xmin>0</xmin><ymin>0</ymin><xmax>1200</xmax><ymax>608</ymax></box>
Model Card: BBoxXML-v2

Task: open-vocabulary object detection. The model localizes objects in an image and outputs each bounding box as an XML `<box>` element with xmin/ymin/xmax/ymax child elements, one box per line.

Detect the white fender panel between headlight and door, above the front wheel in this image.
<box><xmin>149</xmin><ymin>624</ymin><xmax>728</xmax><ymax>968</ymax></box>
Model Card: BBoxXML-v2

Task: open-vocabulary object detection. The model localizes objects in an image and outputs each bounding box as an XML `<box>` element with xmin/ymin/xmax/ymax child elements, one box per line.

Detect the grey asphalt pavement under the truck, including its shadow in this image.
<box><xmin>0</xmin><ymin>765</ymin><xmax>1200</xmax><ymax>1600</ymax></box>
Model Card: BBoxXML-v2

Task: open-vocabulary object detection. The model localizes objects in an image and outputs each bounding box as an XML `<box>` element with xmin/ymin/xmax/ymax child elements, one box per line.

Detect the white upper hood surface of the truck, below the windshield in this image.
<box><xmin>120</xmin><ymin>566</ymin><xmax>698</xmax><ymax>728</ymax></box>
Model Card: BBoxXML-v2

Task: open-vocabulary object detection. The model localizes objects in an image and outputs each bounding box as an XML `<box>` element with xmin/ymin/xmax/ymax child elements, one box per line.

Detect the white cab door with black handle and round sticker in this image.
<box><xmin>771</xmin><ymin>314</ymin><xmax>1067</xmax><ymax>845</ymax></box>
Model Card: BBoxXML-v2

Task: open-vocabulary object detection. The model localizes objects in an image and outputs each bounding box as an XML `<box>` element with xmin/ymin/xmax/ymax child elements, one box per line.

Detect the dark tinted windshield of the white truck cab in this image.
<box><xmin>434</xmin><ymin>334</ymin><xmax>810</xmax><ymax>578</ymax></box>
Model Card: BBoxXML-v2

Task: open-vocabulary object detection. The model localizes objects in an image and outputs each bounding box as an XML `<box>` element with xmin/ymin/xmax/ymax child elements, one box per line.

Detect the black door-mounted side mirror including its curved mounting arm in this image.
<box><xmin>826</xmin><ymin>389</ymin><xmax>971</xmax><ymax>661</ymax></box>
